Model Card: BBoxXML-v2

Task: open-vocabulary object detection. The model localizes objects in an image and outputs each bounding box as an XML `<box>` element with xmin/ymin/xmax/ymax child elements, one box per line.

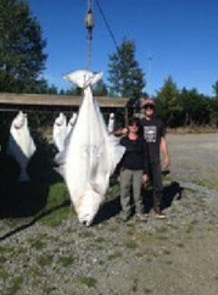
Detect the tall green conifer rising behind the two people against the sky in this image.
<box><xmin>108</xmin><ymin>40</ymin><xmax>145</xmax><ymax>99</ymax></box>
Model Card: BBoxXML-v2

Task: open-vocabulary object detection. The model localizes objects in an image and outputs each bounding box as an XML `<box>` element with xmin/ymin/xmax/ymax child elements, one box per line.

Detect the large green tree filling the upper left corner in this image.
<box><xmin>0</xmin><ymin>0</ymin><xmax>47</xmax><ymax>93</ymax></box>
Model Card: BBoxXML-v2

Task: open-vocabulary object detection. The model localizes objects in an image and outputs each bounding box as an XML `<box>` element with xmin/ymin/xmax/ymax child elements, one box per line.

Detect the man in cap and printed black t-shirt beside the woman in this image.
<box><xmin>141</xmin><ymin>98</ymin><xmax>169</xmax><ymax>218</ymax></box>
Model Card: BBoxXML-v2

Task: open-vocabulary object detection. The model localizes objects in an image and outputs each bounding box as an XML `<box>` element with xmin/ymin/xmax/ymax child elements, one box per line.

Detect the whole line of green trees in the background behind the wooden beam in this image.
<box><xmin>0</xmin><ymin>0</ymin><xmax>218</xmax><ymax>127</ymax></box>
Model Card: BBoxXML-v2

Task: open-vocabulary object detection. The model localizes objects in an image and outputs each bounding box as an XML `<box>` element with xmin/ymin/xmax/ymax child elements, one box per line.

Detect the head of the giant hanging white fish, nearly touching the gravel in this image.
<box><xmin>77</xmin><ymin>189</ymin><xmax>104</xmax><ymax>226</ymax></box>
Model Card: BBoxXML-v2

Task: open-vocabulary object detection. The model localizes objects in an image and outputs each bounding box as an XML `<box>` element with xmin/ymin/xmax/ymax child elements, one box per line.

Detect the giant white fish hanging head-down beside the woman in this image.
<box><xmin>64</xmin><ymin>70</ymin><xmax>125</xmax><ymax>226</ymax></box>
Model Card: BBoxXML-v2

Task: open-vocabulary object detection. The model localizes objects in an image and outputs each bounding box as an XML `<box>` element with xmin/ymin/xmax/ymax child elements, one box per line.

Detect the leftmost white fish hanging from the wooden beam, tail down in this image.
<box><xmin>7</xmin><ymin>111</ymin><xmax>36</xmax><ymax>181</ymax></box>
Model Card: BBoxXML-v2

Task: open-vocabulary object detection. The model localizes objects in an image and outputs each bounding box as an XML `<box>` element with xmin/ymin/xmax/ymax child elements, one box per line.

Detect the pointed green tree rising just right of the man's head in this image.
<box><xmin>156</xmin><ymin>76</ymin><xmax>182</xmax><ymax>127</ymax></box>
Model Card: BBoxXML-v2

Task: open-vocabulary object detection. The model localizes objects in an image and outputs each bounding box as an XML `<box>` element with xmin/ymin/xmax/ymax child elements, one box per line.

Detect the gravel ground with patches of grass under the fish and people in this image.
<box><xmin>0</xmin><ymin>133</ymin><xmax>218</xmax><ymax>295</ymax></box>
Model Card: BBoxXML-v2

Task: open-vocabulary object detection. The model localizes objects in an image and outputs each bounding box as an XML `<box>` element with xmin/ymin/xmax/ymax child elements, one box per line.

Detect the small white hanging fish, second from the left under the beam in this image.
<box><xmin>53</xmin><ymin>113</ymin><xmax>67</xmax><ymax>152</ymax></box>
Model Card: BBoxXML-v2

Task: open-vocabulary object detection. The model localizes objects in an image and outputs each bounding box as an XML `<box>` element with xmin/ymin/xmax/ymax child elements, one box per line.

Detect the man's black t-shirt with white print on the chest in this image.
<box><xmin>141</xmin><ymin>118</ymin><xmax>166</xmax><ymax>162</ymax></box>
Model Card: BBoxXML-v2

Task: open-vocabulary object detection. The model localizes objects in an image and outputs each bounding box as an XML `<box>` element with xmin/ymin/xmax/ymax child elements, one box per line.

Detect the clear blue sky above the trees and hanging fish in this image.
<box><xmin>27</xmin><ymin>0</ymin><xmax>218</xmax><ymax>96</ymax></box>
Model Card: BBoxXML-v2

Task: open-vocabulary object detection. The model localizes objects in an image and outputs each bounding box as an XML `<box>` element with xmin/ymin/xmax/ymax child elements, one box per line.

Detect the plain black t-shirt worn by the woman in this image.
<box><xmin>120</xmin><ymin>135</ymin><xmax>149</xmax><ymax>173</ymax></box>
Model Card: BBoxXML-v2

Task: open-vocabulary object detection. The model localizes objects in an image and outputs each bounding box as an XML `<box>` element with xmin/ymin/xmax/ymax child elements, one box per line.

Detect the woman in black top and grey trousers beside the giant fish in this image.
<box><xmin>120</xmin><ymin>117</ymin><xmax>149</xmax><ymax>221</ymax></box>
